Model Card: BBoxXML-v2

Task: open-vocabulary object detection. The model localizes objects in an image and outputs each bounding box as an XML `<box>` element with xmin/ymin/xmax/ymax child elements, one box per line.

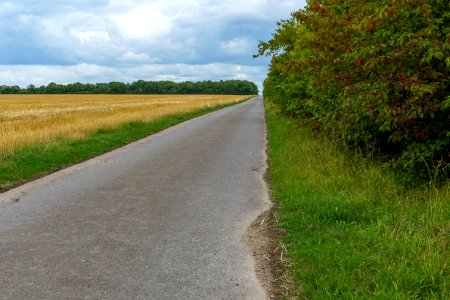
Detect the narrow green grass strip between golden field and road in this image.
<box><xmin>0</xmin><ymin>98</ymin><xmax>249</xmax><ymax>191</ymax></box>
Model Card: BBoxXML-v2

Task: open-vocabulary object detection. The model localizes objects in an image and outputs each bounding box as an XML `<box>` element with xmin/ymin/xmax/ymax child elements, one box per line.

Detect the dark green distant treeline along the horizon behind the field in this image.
<box><xmin>0</xmin><ymin>80</ymin><xmax>258</xmax><ymax>95</ymax></box>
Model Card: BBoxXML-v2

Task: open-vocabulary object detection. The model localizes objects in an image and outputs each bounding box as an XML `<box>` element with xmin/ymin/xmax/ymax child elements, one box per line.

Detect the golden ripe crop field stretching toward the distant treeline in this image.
<box><xmin>0</xmin><ymin>95</ymin><xmax>244</xmax><ymax>159</ymax></box>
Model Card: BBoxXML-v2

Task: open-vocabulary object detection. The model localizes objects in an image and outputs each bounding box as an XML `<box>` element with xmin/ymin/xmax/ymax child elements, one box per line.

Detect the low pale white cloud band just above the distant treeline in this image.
<box><xmin>0</xmin><ymin>63</ymin><xmax>266</xmax><ymax>87</ymax></box>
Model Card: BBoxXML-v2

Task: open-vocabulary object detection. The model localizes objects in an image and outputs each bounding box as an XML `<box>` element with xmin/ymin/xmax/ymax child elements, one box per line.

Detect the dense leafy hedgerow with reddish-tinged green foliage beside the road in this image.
<box><xmin>259</xmin><ymin>0</ymin><xmax>450</xmax><ymax>182</ymax></box>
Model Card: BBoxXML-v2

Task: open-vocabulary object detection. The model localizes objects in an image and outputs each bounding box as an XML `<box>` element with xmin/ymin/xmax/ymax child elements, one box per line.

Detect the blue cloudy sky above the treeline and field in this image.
<box><xmin>0</xmin><ymin>0</ymin><xmax>305</xmax><ymax>91</ymax></box>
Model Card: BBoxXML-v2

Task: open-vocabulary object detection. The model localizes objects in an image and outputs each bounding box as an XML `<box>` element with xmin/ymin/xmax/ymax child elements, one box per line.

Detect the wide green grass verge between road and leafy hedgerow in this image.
<box><xmin>266</xmin><ymin>103</ymin><xmax>450</xmax><ymax>299</ymax></box>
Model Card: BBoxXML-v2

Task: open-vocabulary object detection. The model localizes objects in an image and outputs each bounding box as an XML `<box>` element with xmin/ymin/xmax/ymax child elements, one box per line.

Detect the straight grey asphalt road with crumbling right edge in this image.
<box><xmin>0</xmin><ymin>97</ymin><xmax>269</xmax><ymax>299</ymax></box>
